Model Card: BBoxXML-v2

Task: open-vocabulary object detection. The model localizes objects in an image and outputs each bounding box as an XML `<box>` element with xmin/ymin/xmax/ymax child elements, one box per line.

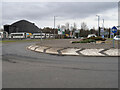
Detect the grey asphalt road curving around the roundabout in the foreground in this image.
<box><xmin>2</xmin><ymin>42</ymin><xmax>118</xmax><ymax>88</ymax></box>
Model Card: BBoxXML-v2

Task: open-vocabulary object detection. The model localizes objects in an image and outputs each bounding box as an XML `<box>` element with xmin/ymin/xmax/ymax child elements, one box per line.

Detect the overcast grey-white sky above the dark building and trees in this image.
<box><xmin>2</xmin><ymin>2</ymin><xmax>118</xmax><ymax>29</ymax></box>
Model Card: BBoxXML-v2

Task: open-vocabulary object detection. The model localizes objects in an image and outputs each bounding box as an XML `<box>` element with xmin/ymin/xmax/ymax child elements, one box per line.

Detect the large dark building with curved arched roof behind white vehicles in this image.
<box><xmin>4</xmin><ymin>20</ymin><xmax>40</xmax><ymax>34</ymax></box>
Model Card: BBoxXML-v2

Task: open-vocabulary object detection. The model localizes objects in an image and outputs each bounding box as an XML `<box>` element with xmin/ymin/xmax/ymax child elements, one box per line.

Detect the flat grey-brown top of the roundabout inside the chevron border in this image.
<box><xmin>37</xmin><ymin>39</ymin><xmax>119</xmax><ymax>49</ymax></box>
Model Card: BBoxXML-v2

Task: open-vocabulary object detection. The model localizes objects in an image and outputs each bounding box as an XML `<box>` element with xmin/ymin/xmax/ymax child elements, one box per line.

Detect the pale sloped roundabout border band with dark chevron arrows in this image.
<box><xmin>27</xmin><ymin>45</ymin><xmax>120</xmax><ymax>57</ymax></box>
